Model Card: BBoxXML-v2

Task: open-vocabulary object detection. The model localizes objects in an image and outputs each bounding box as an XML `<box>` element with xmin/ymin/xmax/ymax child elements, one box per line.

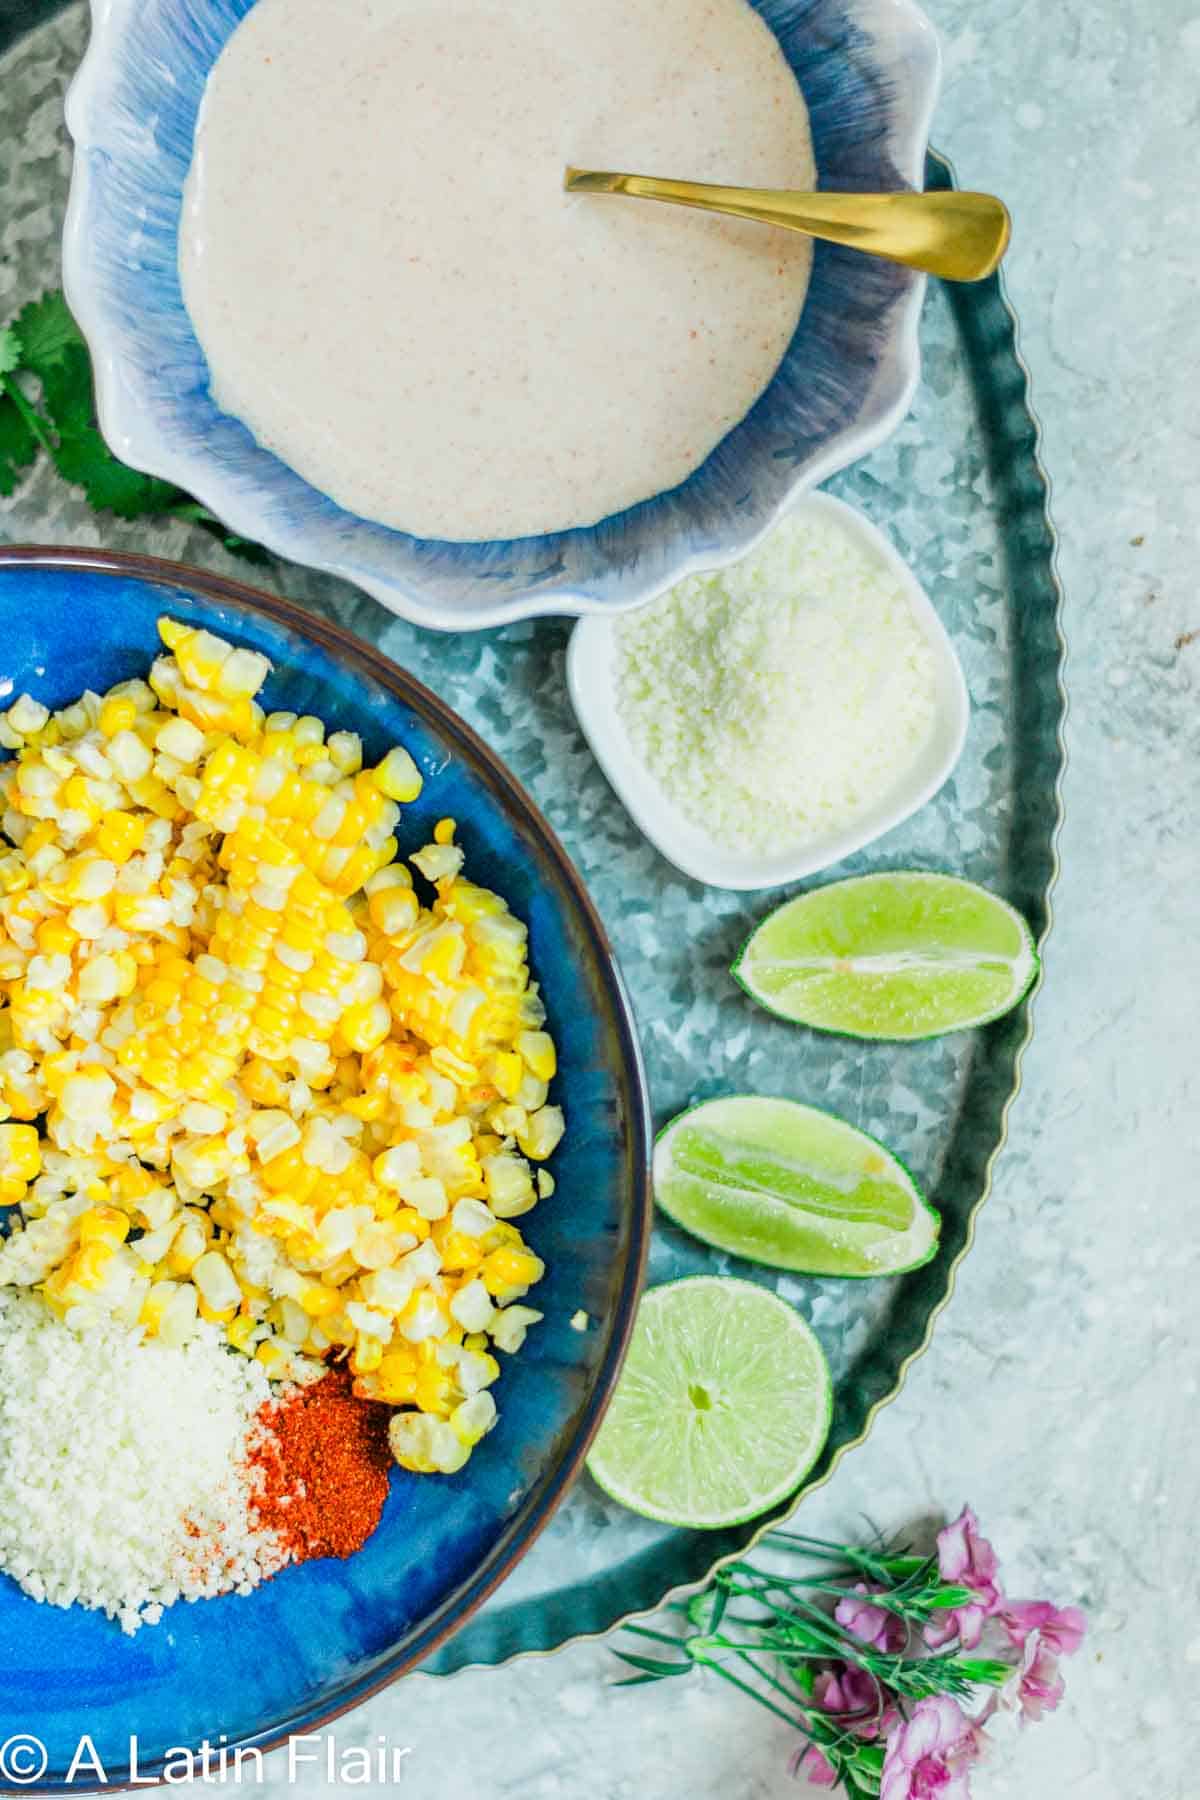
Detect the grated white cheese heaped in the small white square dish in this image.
<box><xmin>617</xmin><ymin>509</ymin><xmax>936</xmax><ymax>850</ymax></box>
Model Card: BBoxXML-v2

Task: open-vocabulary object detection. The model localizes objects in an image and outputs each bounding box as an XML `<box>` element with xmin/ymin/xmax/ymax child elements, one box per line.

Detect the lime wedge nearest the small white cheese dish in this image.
<box><xmin>734</xmin><ymin>871</ymin><xmax>1038</xmax><ymax>1039</ymax></box>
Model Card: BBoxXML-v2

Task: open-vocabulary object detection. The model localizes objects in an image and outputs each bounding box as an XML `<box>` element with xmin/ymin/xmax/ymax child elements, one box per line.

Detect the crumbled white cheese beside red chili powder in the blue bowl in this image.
<box><xmin>0</xmin><ymin>1291</ymin><xmax>288</xmax><ymax>1633</ymax></box>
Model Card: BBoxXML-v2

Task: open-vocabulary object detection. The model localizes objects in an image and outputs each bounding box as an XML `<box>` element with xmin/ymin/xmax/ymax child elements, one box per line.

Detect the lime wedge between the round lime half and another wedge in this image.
<box><xmin>655</xmin><ymin>1094</ymin><xmax>941</xmax><ymax>1274</ymax></box>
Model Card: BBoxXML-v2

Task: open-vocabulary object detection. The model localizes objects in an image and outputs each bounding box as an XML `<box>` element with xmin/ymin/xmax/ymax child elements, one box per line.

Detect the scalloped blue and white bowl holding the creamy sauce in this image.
<box><xmin>63</xmin><ymin>0</ymin><xmax>939</xmax><ymax>630</ymax></box>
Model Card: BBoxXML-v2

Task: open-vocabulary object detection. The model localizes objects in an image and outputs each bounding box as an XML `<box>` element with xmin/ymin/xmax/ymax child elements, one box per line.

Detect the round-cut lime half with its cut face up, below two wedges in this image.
<box><xmin>588</xmin><ymin>1274</ymin><xmax>833</xmax><ymax>1530</ymax></box>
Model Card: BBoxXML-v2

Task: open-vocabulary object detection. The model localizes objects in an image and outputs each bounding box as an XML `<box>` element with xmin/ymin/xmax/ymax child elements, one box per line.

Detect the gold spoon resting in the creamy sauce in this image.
<box><xmin>563</xmin><ymin>169</ymin><xmax>1011</xmax><ymax>281</ymax></box>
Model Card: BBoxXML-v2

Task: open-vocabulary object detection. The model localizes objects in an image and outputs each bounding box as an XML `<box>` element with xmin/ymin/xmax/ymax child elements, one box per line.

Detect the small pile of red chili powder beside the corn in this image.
<box><xmin>250</xmin><ymin>1368</ymin><xmax>392</xmax><ymax>1562</ymax></box>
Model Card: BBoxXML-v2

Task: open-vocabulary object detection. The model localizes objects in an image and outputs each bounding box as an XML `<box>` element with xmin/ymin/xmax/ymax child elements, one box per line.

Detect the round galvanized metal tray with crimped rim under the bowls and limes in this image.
<box><xmin>0</xmin><ymin>0</ymin><xmax>1065</xmax><ymax>1674</ymax></box>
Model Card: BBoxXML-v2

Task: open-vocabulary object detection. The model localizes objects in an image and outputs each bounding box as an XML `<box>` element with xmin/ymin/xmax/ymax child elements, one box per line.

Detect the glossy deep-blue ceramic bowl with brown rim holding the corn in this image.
<box><xmin>0</xmin><ymin>549</ymin><xmax>649</xmax><ymax>1789</ymax></box>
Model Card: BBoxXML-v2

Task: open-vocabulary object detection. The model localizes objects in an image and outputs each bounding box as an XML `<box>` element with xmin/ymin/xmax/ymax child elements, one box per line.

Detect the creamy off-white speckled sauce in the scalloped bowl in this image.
<box><xmin>180</xmin><ymin>0</ymin><xmax>813</xmax><ymax>540</ymax></box>
